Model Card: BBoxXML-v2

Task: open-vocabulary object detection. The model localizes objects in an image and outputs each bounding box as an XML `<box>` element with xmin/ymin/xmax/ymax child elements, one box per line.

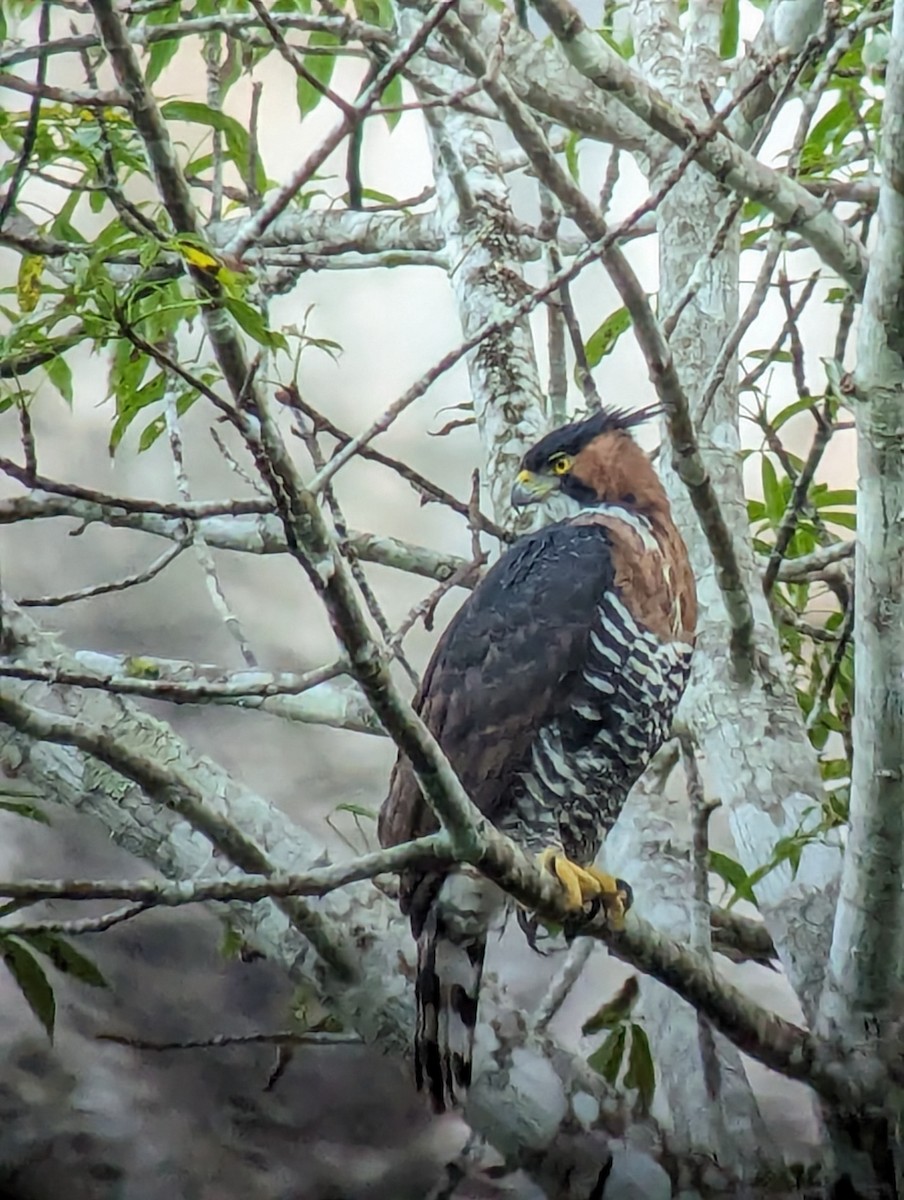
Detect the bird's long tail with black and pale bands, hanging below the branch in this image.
<box><xmin>414</xmin><ymin>872</ymin><xmax>495</xmax><ymax>1112</ymax></box>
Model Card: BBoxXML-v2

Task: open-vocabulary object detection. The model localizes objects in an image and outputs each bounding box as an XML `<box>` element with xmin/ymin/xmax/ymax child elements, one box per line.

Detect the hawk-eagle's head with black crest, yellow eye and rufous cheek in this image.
<box><xmin>511</xmin><ymin>407</ymin><xmax>667</xmax><ymax>515</ymax></box>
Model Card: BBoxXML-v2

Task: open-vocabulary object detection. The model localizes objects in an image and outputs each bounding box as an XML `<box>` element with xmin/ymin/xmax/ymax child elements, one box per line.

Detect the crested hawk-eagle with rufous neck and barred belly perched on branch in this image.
<box><xmin>379</xmin><ymin>410</ymin><xmax>696</xmax><ymax>1111</ymax></box>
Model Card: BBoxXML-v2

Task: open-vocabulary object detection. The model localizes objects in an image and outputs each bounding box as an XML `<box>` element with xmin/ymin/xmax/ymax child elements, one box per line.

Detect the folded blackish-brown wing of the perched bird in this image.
<box><xmin>379</xmin><ymin>522</ymin><xmax>615</xmax><ymax>846</ymax></box>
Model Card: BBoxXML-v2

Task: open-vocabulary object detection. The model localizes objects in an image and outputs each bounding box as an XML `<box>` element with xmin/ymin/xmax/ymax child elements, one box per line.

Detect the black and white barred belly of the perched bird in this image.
<box><xmin>504</xmin><ymin>592</ymin><xmax>693</xmax><ymax>864</ymax></box>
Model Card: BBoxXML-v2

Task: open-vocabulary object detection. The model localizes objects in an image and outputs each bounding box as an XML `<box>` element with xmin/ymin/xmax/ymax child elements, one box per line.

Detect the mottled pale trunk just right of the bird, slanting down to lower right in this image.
<box><xmin>614</xmin><ymin>2</ymin><xmax>840</xmax><ymax>1032</ymax></box>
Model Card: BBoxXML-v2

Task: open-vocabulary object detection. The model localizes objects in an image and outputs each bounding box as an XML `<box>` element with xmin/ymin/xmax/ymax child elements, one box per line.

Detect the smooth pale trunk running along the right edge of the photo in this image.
<box><xmin>820</xmin><ymin>0</ymin><xmax>904</xmax><ymax>1040</ymax></box>
